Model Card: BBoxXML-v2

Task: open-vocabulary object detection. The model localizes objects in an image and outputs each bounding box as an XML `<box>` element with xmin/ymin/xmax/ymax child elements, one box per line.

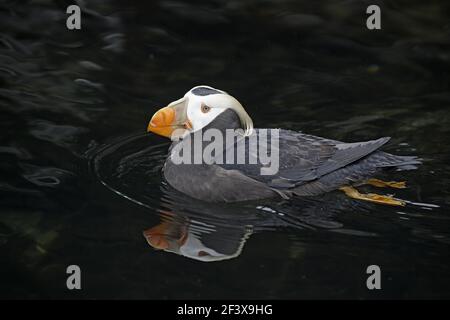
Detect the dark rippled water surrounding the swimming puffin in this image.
<box><xmin>0</xmin><ymin>0</ymin><xmax>450</xmax><ymax>299</ymax></box>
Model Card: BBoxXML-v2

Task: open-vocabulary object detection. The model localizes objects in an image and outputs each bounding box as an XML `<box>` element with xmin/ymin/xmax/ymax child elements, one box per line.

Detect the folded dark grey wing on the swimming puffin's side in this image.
<box><xmin>221</xmin><ymin>129</ymin><xmax>389</xmax><ymax>188</ymax></box>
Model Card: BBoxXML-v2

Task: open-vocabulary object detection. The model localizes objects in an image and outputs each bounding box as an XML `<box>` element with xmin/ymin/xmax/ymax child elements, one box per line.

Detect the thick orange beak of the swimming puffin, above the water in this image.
<box><xmin>147</xmin><ymin>98</ymin><xmax>192</xmax><ymax>138</ymax></box>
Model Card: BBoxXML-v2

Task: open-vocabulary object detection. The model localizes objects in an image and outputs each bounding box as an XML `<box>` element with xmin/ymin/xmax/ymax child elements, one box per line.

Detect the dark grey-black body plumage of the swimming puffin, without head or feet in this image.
<box><xmin>164</xmin><ymin>109</ymin><xmax>420</xmax><ymax>202</ymax></box>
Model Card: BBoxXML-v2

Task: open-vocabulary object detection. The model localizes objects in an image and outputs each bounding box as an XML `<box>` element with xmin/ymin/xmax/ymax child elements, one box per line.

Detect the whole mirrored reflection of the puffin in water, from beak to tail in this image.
<box><xmin>143</xmin><ymin>187</ymin><xmax>384</xmax><ymax>262</ymax></box>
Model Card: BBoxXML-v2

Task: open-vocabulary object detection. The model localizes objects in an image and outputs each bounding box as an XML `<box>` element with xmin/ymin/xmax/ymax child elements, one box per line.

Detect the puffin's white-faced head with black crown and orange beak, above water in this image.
<box><xmin>147</xmin><ymin>86</ymin><xmax>253</xmax><ymax>140</ymax></box>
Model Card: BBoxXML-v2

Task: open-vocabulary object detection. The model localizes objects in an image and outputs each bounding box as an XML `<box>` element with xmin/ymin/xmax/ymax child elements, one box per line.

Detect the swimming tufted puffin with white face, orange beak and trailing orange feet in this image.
<box><xmin>147</xmin><ymin>85</ymin><xmax>421</xmax><ymax>206</ymax></box>
